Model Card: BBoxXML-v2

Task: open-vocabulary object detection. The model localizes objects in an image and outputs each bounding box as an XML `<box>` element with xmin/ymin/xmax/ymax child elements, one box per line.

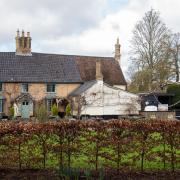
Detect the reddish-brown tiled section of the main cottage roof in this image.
<box><xmin>76</xmin><ymin>56</ymin><xmax>127</xmax><ymax>85</ymax></box>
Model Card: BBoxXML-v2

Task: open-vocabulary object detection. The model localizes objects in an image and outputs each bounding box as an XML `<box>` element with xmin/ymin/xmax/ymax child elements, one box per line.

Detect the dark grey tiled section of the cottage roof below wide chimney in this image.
<box><xmin>0</xmin><ymin>52</ymin><xmax>82</xmax><ymax>83</ymax></box>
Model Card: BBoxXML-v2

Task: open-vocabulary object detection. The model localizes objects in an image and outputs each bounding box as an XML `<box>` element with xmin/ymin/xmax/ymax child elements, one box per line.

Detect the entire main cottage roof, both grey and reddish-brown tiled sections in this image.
<box><xmin>0</xmin><ymin>52</ymin><xmax>126</xmax><ymax>85</ymax></box>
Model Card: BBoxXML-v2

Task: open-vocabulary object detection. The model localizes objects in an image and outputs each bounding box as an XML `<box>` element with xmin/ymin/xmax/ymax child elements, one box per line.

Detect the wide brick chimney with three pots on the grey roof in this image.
<box><xmin>15</xmin><ymin>30</ymin><xmax>32</xmax><ymax>56</ymax></box>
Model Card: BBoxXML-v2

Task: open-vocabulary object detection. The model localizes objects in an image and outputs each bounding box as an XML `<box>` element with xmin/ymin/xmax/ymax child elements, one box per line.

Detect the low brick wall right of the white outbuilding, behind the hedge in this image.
<box><xmin>140</xmin><ymin>111</ymin><xmax>175</xmax><ymax>120</ymax></box>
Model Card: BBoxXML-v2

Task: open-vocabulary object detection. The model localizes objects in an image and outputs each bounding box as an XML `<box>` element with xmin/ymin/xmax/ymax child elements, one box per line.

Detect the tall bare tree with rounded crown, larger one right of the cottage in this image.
<box><xmin>131</xmin><ymin>9</ymin><xmax>171</xmax><ymax>91</ymax></box>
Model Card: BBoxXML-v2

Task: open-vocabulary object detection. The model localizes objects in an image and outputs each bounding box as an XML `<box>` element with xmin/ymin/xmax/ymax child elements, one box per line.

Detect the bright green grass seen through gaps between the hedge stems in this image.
<box><xmin>0</xmin><ymin>132</ymin><xmax>180</xmax><ymax>170</ymax></box>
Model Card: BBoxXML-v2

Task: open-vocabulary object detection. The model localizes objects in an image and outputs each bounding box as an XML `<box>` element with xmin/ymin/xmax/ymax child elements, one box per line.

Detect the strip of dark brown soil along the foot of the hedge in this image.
<box><xmin>0</xmin><ymin>169</ymin><xmax>180</xmax><ymax>180</ymax></box>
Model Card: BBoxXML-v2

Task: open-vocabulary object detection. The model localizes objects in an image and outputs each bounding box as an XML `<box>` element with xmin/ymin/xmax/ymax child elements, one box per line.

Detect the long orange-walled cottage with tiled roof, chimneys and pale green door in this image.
<box><xmin>0</xmin><ymin>31</ymin><xmax>127</xmax><ymax>118</ymax></box>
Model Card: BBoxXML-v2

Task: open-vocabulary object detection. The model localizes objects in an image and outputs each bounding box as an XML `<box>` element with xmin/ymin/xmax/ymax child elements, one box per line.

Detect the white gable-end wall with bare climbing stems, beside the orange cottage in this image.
<box><xmin>81</xmin><ymin>82</ymin><xmax>141</xmax><ymax>116</ymax></box>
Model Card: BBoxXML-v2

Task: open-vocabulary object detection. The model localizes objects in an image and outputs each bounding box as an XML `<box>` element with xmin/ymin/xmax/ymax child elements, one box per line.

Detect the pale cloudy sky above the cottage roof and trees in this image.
<box><xmin>0</xmin><ymin>0</ymin><xmax>180</xmax><ymax>77</ymax></box>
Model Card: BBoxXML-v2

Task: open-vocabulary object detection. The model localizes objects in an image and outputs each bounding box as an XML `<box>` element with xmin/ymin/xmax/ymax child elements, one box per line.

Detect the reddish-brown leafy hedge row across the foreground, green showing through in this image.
<box><xmin>0</xmin><ymin>120</ymin><xmax>180</xmax><ymax>171</ymax></box>
